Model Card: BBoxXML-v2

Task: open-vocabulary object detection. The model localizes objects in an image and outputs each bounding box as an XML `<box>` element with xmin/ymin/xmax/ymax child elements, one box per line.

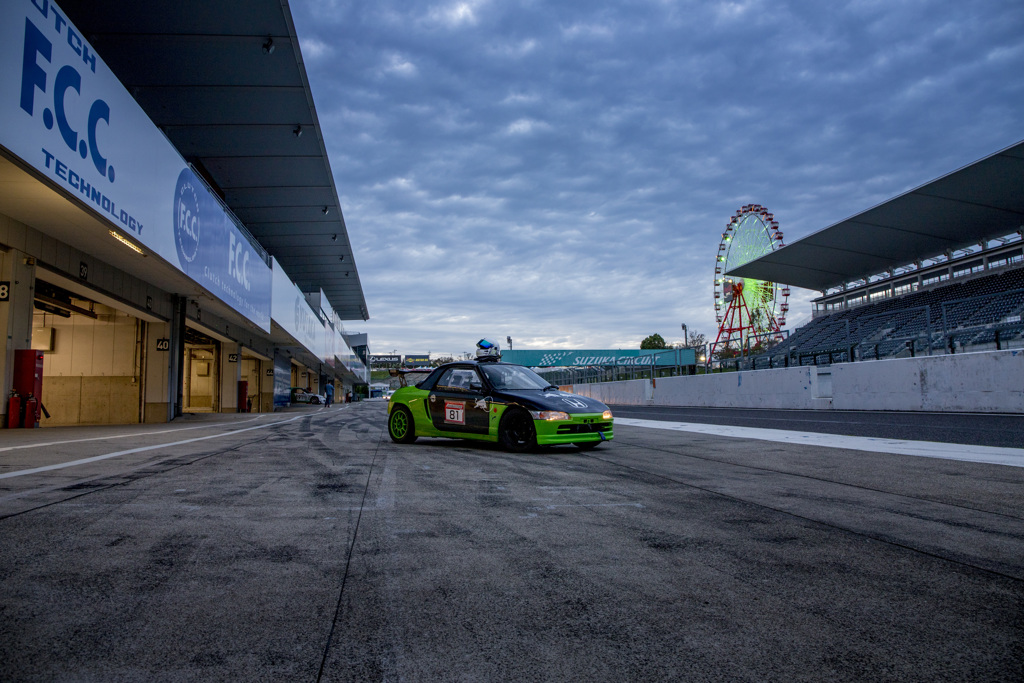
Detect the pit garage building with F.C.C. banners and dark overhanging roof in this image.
<box><xmin>0</xmin><ymin>0</ymin><xmax>369</xmax><ymax>426</ymax></box>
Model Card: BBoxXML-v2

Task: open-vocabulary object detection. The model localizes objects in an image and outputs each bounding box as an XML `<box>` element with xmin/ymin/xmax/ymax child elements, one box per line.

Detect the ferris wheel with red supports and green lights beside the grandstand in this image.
<box><xmin>711</xmin><ymin>204</ymin><xmax>790</xmax><ymax>355</ymax></box>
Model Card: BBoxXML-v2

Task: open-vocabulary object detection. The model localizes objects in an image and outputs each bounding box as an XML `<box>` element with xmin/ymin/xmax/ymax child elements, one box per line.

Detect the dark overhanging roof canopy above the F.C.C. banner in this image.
<box><xmin>59</xmin><ymin>0</ymin><xmax>369</xmax><ymax>321</ymax></box>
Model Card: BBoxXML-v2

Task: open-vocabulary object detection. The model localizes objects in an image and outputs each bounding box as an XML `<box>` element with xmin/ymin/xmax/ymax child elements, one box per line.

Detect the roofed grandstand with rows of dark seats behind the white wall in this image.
<box><xmin>726</xmin><ymin>142</ymin><xmax>1024</xmax><ymax>369</ymax></box>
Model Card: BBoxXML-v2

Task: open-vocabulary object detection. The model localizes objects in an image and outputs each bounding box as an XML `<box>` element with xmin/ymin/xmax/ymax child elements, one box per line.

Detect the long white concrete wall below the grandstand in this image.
<box><xmin>572</xmin><ymin>349</ymin><xmax>1024</xmax><ymax>414</ymax></box>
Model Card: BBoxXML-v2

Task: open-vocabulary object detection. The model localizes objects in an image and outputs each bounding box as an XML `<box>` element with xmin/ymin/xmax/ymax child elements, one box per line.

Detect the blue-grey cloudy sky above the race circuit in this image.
<box><xmin>291</xmin><ymin>0</ymin><xmax>1024</xmax><ymax>355</ymax></box>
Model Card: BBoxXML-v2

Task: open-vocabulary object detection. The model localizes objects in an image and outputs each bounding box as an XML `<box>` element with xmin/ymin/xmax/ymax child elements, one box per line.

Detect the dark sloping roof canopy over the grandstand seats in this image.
<box><xmin>726</xmin><ymin>142</ymin><xmax>1024</xmax><ymax>292</ymax></box>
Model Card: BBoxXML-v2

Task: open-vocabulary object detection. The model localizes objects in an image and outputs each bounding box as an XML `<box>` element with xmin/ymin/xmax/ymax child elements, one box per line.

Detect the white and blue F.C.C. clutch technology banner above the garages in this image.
<box><xmin>0</xmin><ymin>0</ymin><xmax>271</xmax><ymax>332</ymax></box>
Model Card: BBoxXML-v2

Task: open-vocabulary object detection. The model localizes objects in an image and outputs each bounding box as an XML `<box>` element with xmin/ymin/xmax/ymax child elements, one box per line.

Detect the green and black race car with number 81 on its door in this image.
<box><xmin>387</xmin><ymin>350</ymin><xmax>612</xmax><ymax>453</ymax></box>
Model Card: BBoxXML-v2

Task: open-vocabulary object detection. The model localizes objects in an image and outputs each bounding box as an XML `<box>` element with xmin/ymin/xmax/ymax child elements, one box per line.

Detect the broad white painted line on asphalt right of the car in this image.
<box><xmin>615</xmin><ymin>418</ymin><xmax>1024</xmax><ymax>467</ymax></box>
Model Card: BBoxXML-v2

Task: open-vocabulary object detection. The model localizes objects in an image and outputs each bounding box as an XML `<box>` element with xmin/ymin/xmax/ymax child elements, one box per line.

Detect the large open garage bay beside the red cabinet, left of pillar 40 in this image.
<box><xmin>32</xmin><ymin>273</ymin><xmax>145</xmax><ymax>426</ymax></box>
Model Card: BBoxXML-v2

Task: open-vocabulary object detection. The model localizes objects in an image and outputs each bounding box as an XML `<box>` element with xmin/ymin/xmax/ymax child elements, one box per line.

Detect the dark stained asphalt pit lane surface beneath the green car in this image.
<box><xmin>0</xmin><ymin>402</ymin><xmax>1024</xmax><ymax>681</ymax></box>
